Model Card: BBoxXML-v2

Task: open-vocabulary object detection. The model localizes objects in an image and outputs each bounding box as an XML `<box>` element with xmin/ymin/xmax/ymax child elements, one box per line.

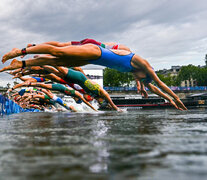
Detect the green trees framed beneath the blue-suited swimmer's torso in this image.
<box><xmin>103</xmin><ymin>68</ymin><xmax>134</xmax><ymax>87</ymax></box>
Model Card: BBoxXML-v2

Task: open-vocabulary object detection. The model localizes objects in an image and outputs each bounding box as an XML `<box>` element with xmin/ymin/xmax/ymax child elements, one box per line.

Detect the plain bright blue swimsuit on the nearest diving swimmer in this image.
<box><xmin>89</xmin><ymin>46</ymin><xmax>134</xmax><ymax>72</ymax></box>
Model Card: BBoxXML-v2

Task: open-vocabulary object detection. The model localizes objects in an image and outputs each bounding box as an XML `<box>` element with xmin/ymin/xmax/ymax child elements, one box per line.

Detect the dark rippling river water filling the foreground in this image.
<box><xmin>0</xmin><ymin>109</ymin><xmax>207</xmax><ymax>180</ymax></box>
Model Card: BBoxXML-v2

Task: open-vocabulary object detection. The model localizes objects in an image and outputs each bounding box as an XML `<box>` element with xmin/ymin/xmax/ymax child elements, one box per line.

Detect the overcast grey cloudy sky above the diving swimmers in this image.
<box><xmin>0</xmin><ymin>0</ymin><xmax>207</xmax><ymax>86</ymax></box>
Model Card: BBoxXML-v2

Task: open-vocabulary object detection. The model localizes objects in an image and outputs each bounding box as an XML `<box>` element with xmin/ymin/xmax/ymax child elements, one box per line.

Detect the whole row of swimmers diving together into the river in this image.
<box><xmin>0</xmin><ymin>39</ymin><xmax>187</xmax><ymax>112</ymax></box>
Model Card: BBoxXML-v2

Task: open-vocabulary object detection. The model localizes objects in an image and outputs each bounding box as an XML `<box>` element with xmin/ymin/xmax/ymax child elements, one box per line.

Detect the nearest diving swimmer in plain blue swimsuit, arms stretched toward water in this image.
<box><xmin>0</xmin><ymin>44</ymin><xmax>187</xmax><ymax>110</ymax></box>
